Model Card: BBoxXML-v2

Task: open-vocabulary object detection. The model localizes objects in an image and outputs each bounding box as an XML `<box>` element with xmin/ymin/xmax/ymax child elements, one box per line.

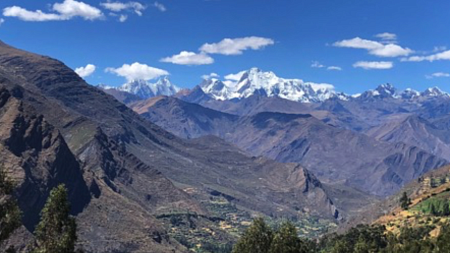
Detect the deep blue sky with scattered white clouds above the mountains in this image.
<box><xmin>0</xmin><ymin>0</ymin><xmax>450</xmax><ymax>93</ymax></box>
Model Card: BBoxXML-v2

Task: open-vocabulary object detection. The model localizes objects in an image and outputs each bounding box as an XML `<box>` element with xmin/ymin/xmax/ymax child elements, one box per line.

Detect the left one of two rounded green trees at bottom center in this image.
<box><xmin>232</xmin><ymin>218</ymin><xmax>273</xmax><ymax>253</ymax></box>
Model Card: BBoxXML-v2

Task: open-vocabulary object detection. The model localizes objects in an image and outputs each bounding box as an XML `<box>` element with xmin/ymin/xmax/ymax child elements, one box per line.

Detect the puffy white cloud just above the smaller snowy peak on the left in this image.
<box><xmin>105</xmin><ymin>62</ymin><xmax>169</xmax><ymax>82</ymax></box>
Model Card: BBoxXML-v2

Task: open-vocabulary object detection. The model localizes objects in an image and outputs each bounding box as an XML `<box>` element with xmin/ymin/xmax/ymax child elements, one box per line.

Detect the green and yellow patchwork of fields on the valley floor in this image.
<box><xmin>157</xmin><ymin>196</ymin><xmax>337</xmax><ymax>253</ymax></box>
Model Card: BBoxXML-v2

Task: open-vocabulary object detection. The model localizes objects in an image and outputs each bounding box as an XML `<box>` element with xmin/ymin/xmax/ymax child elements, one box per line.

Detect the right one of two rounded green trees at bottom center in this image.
<box><xmin>269</xmin><ymin>222</ymin><xmax>310</xmax><ymax>253</ymax></box>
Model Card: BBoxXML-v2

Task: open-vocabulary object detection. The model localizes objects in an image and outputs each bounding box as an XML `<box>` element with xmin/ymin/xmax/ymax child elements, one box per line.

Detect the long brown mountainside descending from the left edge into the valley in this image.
<box><xmin>0</xmin><ymin>42</ymin><xmax>348</xmax><ymax>252</ymax></box>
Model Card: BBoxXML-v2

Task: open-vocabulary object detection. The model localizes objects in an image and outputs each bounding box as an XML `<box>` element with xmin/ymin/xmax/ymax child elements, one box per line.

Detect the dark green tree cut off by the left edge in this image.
<box><xmin>0</xmin><ymin>167</ymin><xmax>21</xmax><ymax>246</ymax></box>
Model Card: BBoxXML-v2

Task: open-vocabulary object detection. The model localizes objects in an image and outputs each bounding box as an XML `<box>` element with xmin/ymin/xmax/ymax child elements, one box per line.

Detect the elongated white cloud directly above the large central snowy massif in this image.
<box><xmin>200</xmin><ymin>36</ymin><xmax>275</xmax><ymax>55</ymax></box>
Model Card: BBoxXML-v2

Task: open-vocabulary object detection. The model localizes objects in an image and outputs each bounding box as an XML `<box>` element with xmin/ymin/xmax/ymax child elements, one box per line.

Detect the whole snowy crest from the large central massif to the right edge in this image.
<box><xmin>199</xmin><ymin>68</ymin><xmax>450</xmax><ymax>103</ymax></box>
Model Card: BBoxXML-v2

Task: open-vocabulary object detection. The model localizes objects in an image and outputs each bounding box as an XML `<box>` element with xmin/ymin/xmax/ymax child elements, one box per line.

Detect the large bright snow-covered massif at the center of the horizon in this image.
<box><xmin>200</xmin><ymin>68</ymin><xmax>342</xmax><ymax>103</ymax></box>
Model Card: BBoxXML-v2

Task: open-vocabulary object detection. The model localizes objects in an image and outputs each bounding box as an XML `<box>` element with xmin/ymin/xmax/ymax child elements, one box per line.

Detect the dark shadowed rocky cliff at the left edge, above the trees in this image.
<box><xmin>0</xmin><ymin>87</ymin><xmax>91</xmax><ymax>229</ymax></box>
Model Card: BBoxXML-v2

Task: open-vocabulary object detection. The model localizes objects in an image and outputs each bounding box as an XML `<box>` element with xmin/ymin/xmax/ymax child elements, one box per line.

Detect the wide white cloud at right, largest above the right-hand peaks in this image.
<box><xmin>333</xmin><ymin>37</ymin><xmax>414</xmax><ymax>57</ymax></box>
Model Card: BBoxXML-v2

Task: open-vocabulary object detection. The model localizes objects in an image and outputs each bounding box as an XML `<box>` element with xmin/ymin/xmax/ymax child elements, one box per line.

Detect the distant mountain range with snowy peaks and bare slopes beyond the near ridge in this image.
<box><xmin>97</xmin><ymin>65</ymin><xmax>450</xmax><ymax>200</ymax></box>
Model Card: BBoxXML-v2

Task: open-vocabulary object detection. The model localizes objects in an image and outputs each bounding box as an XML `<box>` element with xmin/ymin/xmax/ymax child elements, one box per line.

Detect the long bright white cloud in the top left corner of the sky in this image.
<box><xmin>3</xmin><ymin>0</ymin><xmax>103</xmax><ymax>21</ymax></box>
